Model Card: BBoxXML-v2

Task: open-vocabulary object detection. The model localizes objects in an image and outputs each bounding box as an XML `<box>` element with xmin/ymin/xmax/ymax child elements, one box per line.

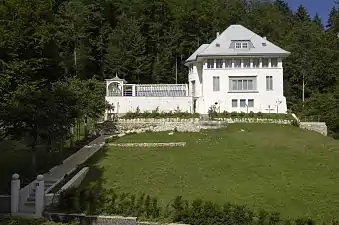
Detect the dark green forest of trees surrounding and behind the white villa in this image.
<box><xmin>0</xmin><ymin>0</ymin><xmax>339</xmax><ymax>140</ymax></box>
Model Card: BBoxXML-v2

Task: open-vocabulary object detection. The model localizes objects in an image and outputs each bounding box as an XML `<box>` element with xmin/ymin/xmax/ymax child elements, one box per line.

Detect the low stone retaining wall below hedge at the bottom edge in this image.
<box><xmin>44</xmin><ymin>213</ymin><xmax>190</xmax><ymax>225</ymax></box>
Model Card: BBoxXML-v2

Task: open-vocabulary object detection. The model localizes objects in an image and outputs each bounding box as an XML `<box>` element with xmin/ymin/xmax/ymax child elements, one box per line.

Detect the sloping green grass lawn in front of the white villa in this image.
<box><xmin>84</xmin><ymin>124</ymin><xmax>339</xmax><ymax>221</ymax></box>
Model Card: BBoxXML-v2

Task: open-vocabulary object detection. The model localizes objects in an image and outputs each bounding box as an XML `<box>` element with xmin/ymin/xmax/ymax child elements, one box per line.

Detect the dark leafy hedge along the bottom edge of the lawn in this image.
<box><xmin>47</xmin><ymin>187</ymin><xmax>339</xmax><ymax>225</ymax></box>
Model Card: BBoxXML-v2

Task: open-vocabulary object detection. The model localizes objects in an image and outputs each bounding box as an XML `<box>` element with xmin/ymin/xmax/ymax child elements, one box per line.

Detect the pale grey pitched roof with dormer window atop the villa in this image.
<box><xmin>186</xmin><ymin>25</ymin><xmax>290</xmax><ymax>62</ymax></box>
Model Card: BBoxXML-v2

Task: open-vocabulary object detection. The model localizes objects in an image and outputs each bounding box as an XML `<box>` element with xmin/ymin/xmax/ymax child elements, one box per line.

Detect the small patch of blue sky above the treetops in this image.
<box><xmin>286</xmin><ymin>0</ymin><xmax>334</xmax><ymax>24</ymax></box>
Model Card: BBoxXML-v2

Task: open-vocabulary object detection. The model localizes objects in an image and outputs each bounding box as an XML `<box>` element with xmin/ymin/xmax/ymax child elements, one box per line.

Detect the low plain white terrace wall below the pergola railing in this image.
<box><xmin>106</xmin><ymin>96</ymin><xmax>193</xmax><ymax>114</ymax></box>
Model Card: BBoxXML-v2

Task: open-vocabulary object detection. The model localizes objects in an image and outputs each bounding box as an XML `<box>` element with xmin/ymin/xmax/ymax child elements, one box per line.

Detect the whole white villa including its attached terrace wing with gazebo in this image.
<box><xmin>106</xmin><ymin>25</ymin><xmax>290</xmax><ymax>116</ymax></box>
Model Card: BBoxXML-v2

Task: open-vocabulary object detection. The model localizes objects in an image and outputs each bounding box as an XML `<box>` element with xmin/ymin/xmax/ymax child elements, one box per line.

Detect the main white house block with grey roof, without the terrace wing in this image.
<box><xmin>185</xmin><ymin>25</ymin><xmax>290</xmax><ymax>114</ymax></box>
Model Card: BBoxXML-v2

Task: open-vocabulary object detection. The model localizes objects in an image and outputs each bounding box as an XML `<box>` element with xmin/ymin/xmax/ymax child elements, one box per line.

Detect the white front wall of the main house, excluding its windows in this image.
<box><xmin>191</xmin><ymin>61</ymin><xmax>287</xmax><ymax>114</ymax></box>
